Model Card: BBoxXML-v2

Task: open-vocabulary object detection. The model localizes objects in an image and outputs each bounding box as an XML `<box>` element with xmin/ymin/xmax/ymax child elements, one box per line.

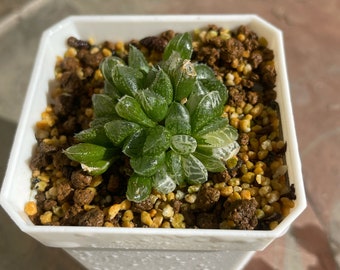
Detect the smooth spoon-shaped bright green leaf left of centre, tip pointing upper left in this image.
<box><xmin>115</xmin><ymin>96</ymin><xmax>156</xmax><ymax>127</ymax></box>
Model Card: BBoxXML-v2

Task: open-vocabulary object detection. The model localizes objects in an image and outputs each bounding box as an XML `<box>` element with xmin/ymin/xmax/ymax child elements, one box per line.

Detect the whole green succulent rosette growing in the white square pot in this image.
<box><xmin>64</xmin><ymin>33</ymin><xmax>239</xmax><ymax>202</ymax></box>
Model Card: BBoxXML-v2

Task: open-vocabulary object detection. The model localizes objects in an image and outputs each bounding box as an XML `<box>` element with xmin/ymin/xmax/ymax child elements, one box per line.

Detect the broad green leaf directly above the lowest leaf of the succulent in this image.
<box><xmin>130</xmin><ymin>152</ymin><xmax>165</xmax><ymax>176</ymax></box>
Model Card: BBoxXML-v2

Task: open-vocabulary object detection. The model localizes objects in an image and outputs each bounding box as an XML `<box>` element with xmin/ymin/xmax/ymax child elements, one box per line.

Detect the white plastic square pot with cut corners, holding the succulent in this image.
<box><xmin>0</xmin><ymin>15</ymin><xmax>306</xmax><ymax>269</ymax></box>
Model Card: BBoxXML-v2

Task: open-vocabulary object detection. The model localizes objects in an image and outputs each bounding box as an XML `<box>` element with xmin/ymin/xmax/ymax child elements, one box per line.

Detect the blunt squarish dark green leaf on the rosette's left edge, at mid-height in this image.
<box><xmin>92</xmin><ymin>94</ymin><xmax>117</xmax><ymax>117</ymax></box>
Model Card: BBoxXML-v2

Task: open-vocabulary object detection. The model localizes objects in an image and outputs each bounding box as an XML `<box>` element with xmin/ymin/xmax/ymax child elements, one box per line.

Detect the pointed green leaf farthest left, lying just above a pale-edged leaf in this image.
<box><xmin>64</xmin><ymin>143</ymin><xmax>114</xmax><ymax>163</ymax></box>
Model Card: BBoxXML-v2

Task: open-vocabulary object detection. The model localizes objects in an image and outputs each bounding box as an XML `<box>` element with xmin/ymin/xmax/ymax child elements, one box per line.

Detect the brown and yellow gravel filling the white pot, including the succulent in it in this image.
<box><xmin>25</xmin><ymin>25</ymin><xmax>295</xmax><ymax>230</ymax></box>
